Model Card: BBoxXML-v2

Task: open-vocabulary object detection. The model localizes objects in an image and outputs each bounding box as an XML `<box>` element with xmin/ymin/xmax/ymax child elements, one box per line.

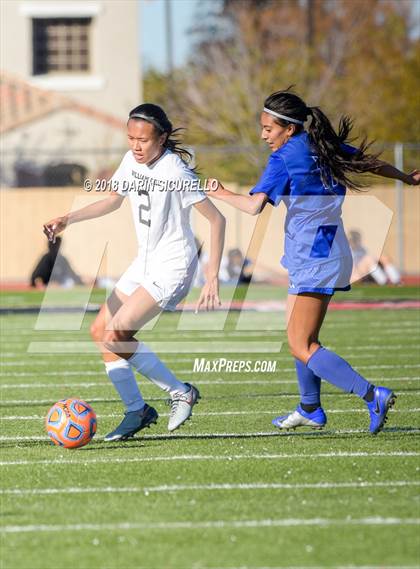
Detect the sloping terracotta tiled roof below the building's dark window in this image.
<box><xmin>0</xmin><ymin>72</ymin><xmax>125</xmax><ymax>134</ymax></box>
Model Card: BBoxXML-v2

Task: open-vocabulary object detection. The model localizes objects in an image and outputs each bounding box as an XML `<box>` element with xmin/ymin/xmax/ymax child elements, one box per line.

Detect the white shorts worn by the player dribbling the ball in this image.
<box><xmin>115</xmin><ymin>257</ymin><xmax>197</xmax><ymax>311</ymax></box>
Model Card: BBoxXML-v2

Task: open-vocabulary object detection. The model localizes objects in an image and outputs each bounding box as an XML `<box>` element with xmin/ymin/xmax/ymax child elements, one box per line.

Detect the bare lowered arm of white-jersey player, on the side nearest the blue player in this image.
<box><xmin>194</xmin><ymin>198</ymin><xmax>226</xmax><ymax>313</ymax></box>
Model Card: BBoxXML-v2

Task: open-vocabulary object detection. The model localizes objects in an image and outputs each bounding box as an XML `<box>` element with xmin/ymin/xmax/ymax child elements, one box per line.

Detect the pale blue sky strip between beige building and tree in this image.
<box><xmin>139</xmin><ymin>0</ymin><xmax>200</xmax><ymax>71</ymax></box>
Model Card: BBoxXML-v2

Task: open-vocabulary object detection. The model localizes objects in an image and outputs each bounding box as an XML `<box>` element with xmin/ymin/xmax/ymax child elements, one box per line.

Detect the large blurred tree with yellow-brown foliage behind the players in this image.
<box><xmin>146</xmin><ymin>0</ymin><xmax>420</xmax><ymax>182</ymax></box>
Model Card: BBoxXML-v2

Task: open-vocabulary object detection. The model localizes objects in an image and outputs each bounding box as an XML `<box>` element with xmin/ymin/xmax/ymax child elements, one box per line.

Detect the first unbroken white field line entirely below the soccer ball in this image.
<box><xmin>0</xmin><ymin>451</ymin><xmax>420</xmax><ymax>466</ymax></box>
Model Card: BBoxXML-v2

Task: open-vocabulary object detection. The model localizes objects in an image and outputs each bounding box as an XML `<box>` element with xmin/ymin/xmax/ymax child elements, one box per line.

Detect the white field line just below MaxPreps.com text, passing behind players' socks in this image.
<box><xmin>0</xmin><ymin>376</ymin><xmax>420</xmax><ymax>390</ymax></box>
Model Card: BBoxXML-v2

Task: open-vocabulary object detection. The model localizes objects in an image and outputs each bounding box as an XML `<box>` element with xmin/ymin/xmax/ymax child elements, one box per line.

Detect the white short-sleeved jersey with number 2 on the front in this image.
<box><xmin>112</xmin><ymin>146</ymin><xmax>206</xmax><ymax>271</ymax></box>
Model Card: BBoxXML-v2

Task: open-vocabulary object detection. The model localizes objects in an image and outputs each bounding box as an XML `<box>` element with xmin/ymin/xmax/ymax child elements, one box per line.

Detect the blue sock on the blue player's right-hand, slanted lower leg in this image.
<box><xmin>306</xmin><ymin>348</ymin><xmax>371</xmax><ymax>397</ymax></box>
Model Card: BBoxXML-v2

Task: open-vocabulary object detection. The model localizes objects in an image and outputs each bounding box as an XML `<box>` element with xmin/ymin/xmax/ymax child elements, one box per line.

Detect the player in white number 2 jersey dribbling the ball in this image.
<box><xmin>44</xmin><ymin>103</ymin><xmax>225</xmax><ymax>441</ymax></box>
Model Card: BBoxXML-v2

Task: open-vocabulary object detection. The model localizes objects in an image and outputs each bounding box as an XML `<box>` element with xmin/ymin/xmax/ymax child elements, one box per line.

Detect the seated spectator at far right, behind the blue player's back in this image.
<box><xmin>349</xmin><ymin>230</ymin><xmax>401</xmax><ymax>285</ymax></box>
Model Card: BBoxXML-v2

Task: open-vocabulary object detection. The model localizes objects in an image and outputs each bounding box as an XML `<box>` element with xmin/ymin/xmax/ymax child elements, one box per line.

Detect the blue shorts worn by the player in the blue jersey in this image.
<box><xmin>288</xmin><ymin>257</ymin><xmax>353</xmax><ymax>296</ymax></box>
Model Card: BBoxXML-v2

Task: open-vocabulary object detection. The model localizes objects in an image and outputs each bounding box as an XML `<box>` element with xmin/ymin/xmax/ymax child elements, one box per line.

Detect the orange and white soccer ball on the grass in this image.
<box><xmin>45</xmin><ymin>399</ymin><xmax>96</xmax><ymax>448</ymax></box>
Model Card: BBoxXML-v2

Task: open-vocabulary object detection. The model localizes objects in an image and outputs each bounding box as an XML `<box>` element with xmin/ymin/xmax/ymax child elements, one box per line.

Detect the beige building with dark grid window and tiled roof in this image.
<box><xmin>0</xmin><ymin>0</ymin><xmax>142</xmax><ymax>186</ymax></box>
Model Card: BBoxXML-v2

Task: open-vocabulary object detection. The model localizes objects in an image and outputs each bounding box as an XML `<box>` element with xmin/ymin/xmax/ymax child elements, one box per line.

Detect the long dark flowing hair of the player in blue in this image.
<box><xmin>264</xmin><ymin>87</ymin><xmax>380</xmax><ymax>191</ymax></box>
